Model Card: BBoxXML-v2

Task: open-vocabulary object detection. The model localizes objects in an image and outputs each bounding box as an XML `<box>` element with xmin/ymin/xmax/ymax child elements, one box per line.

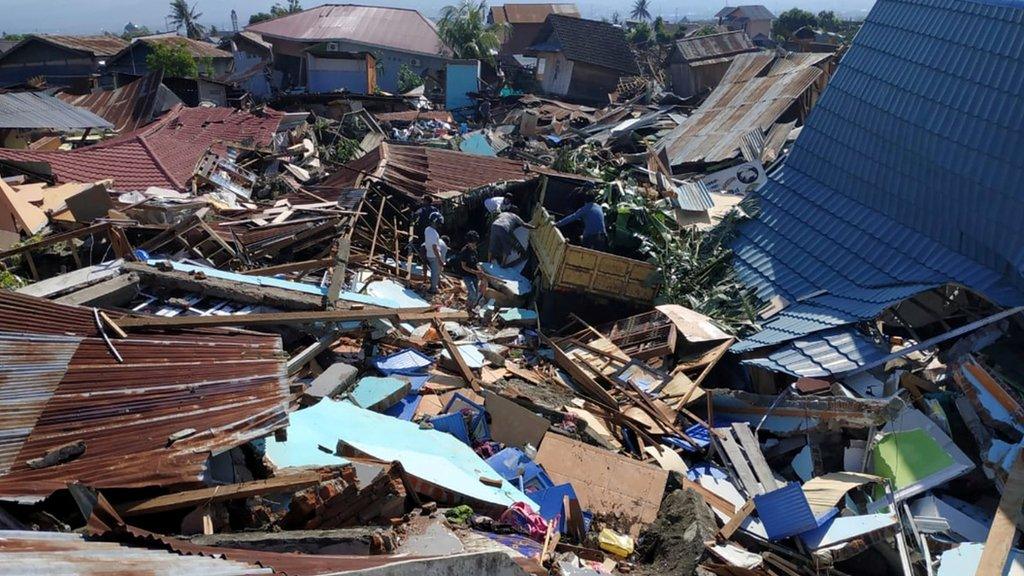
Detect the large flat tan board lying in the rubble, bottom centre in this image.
<box><xmin>536</xmin><ymin>434</ymin><xmax>669</xmax><ymax>537</ymax></box>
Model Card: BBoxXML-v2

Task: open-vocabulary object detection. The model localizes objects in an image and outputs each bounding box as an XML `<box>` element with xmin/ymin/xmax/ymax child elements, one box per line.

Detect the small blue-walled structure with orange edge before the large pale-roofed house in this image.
<box><xmin>306</xmin><ymin>42</ymin><xmax>377</xmax><ymax>94</ymax></box>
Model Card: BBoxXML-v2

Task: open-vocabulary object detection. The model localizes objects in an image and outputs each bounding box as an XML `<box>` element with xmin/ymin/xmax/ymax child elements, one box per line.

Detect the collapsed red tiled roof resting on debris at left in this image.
<box><xmin>0</xmin><ymin>107</ymin><xmax>284</xmax><ymax>191</ymax></box>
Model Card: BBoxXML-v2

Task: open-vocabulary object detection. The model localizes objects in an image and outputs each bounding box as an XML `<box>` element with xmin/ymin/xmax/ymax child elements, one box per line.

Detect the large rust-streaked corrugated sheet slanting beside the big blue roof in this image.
<box><xmin>659</xmin><ymin>53</ymin><xmax>825</xmax><ymax>166</ymax></box>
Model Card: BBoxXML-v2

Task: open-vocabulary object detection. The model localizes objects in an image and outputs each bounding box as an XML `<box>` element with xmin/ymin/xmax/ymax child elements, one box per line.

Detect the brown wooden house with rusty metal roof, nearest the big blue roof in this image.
<box><xmin>668</xmin><ymin>30</ymin><xmax>758</xmax><ymax>98</ymax></box>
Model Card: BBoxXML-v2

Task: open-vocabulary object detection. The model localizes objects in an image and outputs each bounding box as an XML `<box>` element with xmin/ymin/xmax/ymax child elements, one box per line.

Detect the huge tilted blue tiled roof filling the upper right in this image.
<box><xmin>733</xmin><ymin>0</ymin><xmax>1024</xmax><ymax>366</ymax></box>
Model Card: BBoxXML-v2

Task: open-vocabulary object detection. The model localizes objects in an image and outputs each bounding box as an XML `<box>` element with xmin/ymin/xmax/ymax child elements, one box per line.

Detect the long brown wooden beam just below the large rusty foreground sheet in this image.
<box><xmin>118</xmin><ymin>470</ymin><xmax>322</xmax><ymax>517</ymax></box>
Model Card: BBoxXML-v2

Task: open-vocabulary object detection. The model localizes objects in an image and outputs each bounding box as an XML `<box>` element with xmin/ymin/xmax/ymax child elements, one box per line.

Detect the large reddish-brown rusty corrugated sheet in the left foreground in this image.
<box><xmin>0</xmin><ymin>292</ymin><xmax>289</xmax><ymax>501</ymax></box>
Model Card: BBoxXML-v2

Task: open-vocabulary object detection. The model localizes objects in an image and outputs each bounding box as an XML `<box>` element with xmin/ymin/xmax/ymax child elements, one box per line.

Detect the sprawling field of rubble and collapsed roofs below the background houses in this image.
<box><xmin>0</xmin><ymin>0</ymin><xmax>1024</xmax><ymax>576</ymax></box>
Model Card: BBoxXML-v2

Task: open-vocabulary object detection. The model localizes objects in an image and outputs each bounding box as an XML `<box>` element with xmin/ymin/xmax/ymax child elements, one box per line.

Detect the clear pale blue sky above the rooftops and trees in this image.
<box><xmin>0</xmin><ymin>0</ymin><xmax>873</xmax><ymax>34</ymax></box>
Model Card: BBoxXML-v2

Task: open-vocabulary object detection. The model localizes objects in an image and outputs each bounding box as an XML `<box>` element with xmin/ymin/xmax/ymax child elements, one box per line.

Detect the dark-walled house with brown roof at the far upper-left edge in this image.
<box><xmin>0</xmin><ymin>35</ymin><xmax>128</xmax><ymax>89</ymax></box>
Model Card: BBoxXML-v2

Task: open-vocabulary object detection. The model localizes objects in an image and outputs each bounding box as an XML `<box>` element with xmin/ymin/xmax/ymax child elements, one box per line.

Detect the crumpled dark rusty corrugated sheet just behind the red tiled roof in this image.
<box><xmin>58</xmin><ymin>69</ymin><xmax>164</xmax><ymax>132</ymax></box>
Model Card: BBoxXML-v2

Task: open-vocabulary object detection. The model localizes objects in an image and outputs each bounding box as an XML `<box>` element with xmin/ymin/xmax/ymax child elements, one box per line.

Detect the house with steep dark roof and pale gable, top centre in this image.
<box><xmin>527</xmin><ymin>14</ymin><xmax>639</xmax><ymax>102</ymax></box>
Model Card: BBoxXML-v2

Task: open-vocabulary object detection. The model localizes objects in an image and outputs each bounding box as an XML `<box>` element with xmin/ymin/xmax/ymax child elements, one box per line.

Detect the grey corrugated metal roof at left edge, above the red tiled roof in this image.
<box><xmin>0</xmin><ymin>92</ymin><xmax>114</xmax><ymax>130</ymax></box>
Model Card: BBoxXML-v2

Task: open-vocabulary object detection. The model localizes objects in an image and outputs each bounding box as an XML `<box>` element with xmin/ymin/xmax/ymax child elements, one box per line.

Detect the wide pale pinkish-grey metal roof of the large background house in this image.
<box><xmin>246</xmin><ymin>4</ymin><xmax>447</xmax><ymax>55</ymax></box>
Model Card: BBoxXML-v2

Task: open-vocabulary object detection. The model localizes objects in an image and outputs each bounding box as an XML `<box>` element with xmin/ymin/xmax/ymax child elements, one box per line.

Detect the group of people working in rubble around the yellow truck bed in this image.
<box><xmin>413</xmin><ymin>183</ymin><xmax>608</xmax><ymax>311</ymax></box>
